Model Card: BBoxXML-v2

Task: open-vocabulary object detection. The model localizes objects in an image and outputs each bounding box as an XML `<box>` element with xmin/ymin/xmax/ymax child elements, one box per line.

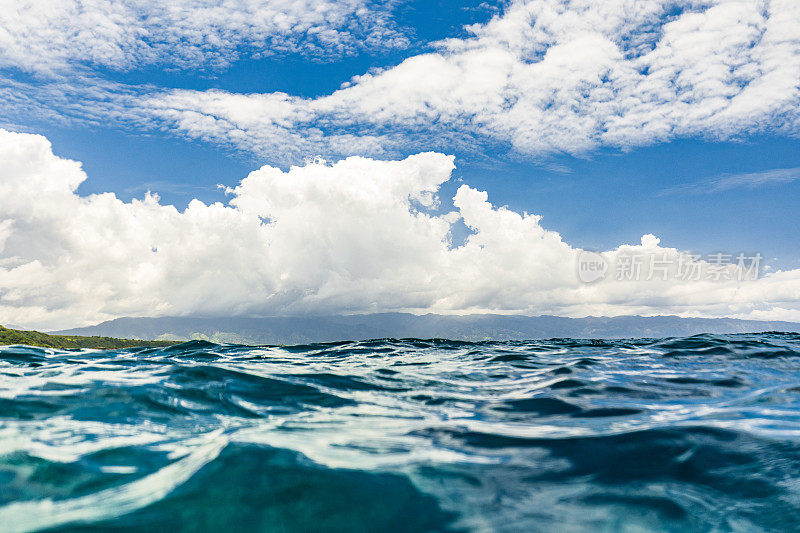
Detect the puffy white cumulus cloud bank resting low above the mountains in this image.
<box><xmin>0</xmin><ymin>130</ymin><xmax>800</xmax><ymax>328</ymax></box>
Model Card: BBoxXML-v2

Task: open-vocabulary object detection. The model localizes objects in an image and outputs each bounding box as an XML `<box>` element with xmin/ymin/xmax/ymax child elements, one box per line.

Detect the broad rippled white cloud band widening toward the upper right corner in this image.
<box><xmin>125</xmin><ymin>0</ymin><xmax>800</xmax><ymax>160</ymax></box>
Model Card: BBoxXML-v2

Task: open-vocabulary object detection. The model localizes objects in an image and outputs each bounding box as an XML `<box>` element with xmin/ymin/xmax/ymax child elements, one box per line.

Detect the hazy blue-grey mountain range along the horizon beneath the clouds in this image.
<box><xmin>53</xmin><ymin>313</ymin><xmax>800</xmax><ymax>344</ymax></box>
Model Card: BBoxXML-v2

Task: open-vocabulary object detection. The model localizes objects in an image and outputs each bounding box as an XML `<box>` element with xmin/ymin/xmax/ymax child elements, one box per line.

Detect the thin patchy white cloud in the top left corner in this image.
<box><xmin>0</xmin><ymin>0</ymin><xmax>408</xmax><ymax>75</ymax></box>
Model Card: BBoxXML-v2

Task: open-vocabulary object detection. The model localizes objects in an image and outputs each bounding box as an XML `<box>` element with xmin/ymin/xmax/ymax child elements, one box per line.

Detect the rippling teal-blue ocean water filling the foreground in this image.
<box><xmin>0</xmin><ymin>333</ymin><xmax>800</xmax><ymax>533</ymax></box>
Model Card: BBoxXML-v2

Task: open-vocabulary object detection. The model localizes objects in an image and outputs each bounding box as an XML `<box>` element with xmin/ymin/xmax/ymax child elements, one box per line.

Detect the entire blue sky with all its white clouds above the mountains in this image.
<box><xmin>0</xmin><ymin>0</ymin><xmax>800</xmax><ymax>329</ymax></box>
